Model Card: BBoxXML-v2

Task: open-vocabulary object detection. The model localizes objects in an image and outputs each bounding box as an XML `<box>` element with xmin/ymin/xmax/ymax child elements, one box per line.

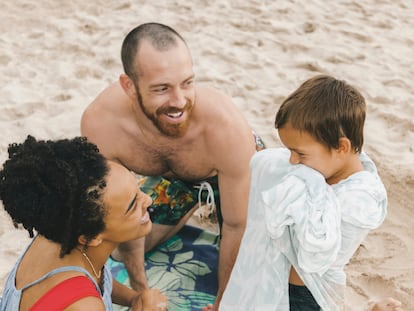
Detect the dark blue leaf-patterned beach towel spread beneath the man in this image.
<box><xmin>107</xmin><ymin>225</ymin><xmax>218</xmax><ymax>311</ymax></box>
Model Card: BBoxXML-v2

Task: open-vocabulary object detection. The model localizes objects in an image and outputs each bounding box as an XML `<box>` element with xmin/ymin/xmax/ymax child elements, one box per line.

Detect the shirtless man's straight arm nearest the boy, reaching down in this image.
<box><xmin>214</xmin><ymin>123</ymin><xmax>255</xmax><ymax>310</ymax></box>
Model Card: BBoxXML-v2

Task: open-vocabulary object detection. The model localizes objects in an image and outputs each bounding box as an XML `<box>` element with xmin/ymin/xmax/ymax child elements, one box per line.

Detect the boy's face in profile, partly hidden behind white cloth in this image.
<box><xmin>278</xmin><ymin>123</ymin><xmax>342</xmax><ymax>184</ymax></box>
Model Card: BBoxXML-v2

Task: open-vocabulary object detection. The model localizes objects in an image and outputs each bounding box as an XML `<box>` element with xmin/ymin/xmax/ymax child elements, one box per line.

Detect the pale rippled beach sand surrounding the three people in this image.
<box><xmin>0</xmin><ymin>0</ymin><xmax>414</xmax><ymax>310</ymax></box>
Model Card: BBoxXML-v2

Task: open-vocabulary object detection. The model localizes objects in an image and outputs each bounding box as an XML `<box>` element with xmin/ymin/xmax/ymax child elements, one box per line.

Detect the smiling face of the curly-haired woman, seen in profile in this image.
<box><xmin>101</xmin><ymin>161</ymin><xmax>152</xmax><ymax>243</ymax></box>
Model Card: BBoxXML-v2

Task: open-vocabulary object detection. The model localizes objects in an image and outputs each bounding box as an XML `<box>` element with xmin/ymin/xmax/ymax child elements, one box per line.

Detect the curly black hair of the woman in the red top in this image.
<box><xmin>0</xmin><ymin>135</ymin><xmax>108</xmax><ymax>257</ymax></box>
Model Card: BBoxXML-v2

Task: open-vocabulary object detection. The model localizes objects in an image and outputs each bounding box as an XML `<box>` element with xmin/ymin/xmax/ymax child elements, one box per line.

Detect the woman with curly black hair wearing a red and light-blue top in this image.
<box><xmin>0</xmin><ymin>136</ymin><xmax>166</xmax><ymax>311</ymax></box>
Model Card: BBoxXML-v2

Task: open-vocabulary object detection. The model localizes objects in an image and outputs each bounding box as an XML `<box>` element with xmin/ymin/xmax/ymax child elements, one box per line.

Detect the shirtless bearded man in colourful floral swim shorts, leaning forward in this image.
<box><xmin>81</xmin><ymin>23</ymin><xmax>263</xmax><ymax>310</ymax></box>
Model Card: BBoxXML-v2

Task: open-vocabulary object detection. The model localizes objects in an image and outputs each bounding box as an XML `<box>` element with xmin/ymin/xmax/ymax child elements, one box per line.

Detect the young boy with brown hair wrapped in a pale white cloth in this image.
<box><xmin>220</xmin><ymin>75</ymin><xmax>391</xmax><ymax>311</ymax></box>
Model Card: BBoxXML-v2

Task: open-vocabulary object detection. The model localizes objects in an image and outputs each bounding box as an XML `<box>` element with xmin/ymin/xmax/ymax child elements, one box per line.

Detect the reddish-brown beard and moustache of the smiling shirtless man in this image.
<box><xmin>136</xmin><ymin>88</ymin><xmax>193</xmax><ymax>137</ymax></box>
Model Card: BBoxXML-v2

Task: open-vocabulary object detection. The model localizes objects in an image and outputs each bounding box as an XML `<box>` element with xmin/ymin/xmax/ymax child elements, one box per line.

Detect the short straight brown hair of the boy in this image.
<box><xmin>275</xmin><ymin>75</ymin><xmax>365</xmax><ymax>153</ymax></box>
